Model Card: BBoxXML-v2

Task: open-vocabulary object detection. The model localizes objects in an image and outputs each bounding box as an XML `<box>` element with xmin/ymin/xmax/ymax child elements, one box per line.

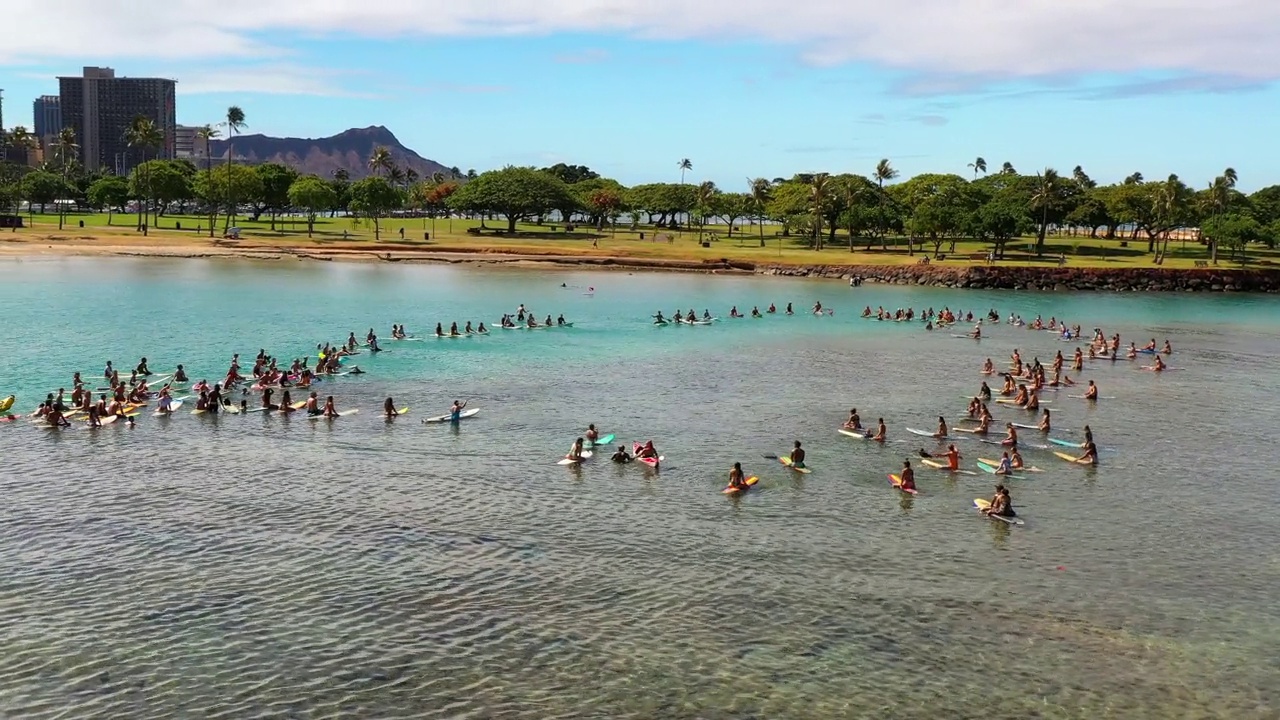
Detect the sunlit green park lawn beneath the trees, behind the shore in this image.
<box><xmin>12</xmin><ymin>213</ymin><xmax>1280</xmax><ymax>269</ymax></box>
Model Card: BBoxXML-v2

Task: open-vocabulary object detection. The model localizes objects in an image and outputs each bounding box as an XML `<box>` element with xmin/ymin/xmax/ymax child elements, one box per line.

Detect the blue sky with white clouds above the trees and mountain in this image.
<box><xmin>0</xmin><ymin>0</ymin><xmax>1280</xmax><ymax>191</ymax></box>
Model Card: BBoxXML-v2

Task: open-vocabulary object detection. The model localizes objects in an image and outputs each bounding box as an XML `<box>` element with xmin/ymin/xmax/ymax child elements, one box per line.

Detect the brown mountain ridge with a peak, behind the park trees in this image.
<box><xmin>209</xmin><ymin>126</ymin><xmax>449</xmax><ymax>179</ymax></box>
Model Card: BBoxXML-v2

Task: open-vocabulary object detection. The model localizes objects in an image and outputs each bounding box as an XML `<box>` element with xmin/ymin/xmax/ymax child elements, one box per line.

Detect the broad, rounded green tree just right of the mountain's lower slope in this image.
<box><xmin>449</xmin><ymin>167</ymin><xmax>571</xmax><ymax>232</ymax></box>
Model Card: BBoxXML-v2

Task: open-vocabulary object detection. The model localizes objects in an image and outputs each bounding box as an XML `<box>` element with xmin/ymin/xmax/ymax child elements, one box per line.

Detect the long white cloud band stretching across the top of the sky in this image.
<box><xmin>0</xmin><ymin>0</ymin><xmax>1280</xmax><ymax>85</ymax></box>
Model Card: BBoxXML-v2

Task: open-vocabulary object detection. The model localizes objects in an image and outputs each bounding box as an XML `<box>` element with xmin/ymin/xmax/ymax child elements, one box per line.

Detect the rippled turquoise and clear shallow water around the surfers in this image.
<box><xmin>0</xmin><ymin>259</ymin><xmax>1280</xmax><ymax>719</ymax></box>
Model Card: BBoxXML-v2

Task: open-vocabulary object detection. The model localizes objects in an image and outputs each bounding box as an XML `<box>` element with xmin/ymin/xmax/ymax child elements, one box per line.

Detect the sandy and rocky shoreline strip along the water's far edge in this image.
<box><xmin>0</xmin><ymin>234</ymin><xmax>1280</xmax><ymax>293</ymax></box>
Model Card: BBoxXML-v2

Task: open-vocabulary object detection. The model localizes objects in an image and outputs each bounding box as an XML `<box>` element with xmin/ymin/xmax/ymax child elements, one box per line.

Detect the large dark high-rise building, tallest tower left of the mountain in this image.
<box><xmin>58</xmin><ymin>68</ymin><xmax>178</xmax><ymax>176</ymax></box>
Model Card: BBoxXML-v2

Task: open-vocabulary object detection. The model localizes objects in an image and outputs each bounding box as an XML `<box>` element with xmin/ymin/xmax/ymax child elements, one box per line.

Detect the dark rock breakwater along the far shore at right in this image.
<box><xmin>755</xmin><ymin>265</ymin><xmax>1280</xmax><ymax>292</ymax></box>
